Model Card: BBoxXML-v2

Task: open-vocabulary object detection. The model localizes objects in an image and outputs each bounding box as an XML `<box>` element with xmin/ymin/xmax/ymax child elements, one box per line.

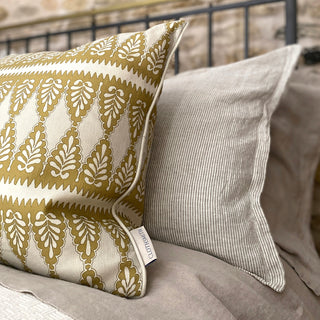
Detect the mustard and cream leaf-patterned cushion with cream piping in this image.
<box><xmin>0</xmin><ymin>21</ymin><xmax>186</xmax><ymax>297</ymax></box>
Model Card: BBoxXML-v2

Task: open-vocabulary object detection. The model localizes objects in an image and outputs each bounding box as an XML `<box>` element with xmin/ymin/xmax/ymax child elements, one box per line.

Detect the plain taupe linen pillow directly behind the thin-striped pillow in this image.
<box><xmin>261</xmin><ymin>70</ymin><xmax>320</xmax><ymax>295</ymax></box>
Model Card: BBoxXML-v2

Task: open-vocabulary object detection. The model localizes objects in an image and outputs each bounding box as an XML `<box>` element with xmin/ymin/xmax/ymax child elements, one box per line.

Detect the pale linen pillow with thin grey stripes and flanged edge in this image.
<box><xmin>144</xmin><ymin>46</ymin><xmax>300</xmax><ymax>291</ymax></box>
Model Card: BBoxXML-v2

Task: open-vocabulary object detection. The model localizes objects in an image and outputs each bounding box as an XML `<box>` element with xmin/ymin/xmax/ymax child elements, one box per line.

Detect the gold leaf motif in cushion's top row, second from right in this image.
<box><xmin>117</xmin><ymin>33</ymin><xmax>145</xmax><ymax>63</ymax></box>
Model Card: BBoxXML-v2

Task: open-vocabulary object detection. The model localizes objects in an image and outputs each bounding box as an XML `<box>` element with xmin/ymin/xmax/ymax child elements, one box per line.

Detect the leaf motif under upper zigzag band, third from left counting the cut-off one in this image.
<box><xmin>38</xmin><ymin>78</ymin><xmax>64</xmax><ymax>117</ymax></box>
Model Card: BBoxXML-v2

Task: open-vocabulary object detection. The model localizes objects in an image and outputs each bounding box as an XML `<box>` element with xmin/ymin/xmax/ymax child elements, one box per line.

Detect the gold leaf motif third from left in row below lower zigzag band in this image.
<box><xmin>68</xmin><ymin>214</ymin><xmax>101</xmax><ymax>264</ymax></box>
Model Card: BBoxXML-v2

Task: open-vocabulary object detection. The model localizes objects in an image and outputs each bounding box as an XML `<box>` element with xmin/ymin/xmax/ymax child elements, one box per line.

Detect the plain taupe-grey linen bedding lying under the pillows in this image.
<box><xmin>0</xmin><ymin>241</ymin><xmax>320</xmax><ymax>320</ymax></box>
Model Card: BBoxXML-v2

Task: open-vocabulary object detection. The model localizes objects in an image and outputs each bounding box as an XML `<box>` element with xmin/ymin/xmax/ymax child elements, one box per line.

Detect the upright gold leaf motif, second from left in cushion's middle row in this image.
<box><xmin>16</xmin><ymin>123</ymin><xmax>45</xmax><ymax>173</ymax></box>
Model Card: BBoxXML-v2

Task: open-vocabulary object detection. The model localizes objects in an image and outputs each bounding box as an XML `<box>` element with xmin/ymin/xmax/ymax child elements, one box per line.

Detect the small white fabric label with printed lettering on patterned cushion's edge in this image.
<box><xmin>130</xmin><ymin>226</ymin><xmax>157</xmax><ymax>266</ymax></box>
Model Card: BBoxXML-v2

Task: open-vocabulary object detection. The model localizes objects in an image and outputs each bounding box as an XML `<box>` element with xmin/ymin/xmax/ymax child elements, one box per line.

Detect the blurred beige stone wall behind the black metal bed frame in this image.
<box><xmin>0</xmin><ymin>0</ymin><xmax>320</xmax><ymax>70</ymax></box>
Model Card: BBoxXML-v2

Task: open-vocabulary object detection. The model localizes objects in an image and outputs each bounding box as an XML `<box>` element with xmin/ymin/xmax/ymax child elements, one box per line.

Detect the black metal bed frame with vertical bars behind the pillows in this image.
<box><xmin>0</xmin><ymin>0</ymin><xmax>297</xmax><ymax>73</ymax></box>
